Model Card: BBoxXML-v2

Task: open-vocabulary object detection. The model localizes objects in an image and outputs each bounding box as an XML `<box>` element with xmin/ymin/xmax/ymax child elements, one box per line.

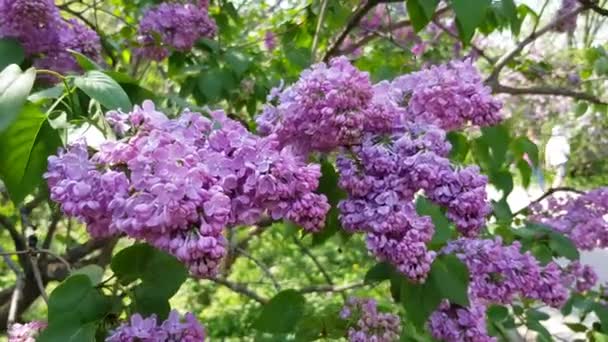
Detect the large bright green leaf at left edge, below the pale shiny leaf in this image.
<box><xmin>0</xmin><ymin>104</ymin><xmax>61</xmax><ymax>203</ymax></box>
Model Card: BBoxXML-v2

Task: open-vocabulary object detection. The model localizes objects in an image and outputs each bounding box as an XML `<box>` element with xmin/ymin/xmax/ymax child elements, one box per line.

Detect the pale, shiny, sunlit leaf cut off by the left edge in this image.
<box><xmin>0</xmin><ymin>64</ymin><xmax>36</xmax><ymax>133</ymax></box>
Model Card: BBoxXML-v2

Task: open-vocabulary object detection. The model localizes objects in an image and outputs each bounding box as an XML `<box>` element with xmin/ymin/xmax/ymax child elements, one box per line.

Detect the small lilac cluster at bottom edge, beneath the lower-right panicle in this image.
<box><xmin>428</xmin><ymin>300</ymin><xmax>497</xmax><ymax>342</ymax></box>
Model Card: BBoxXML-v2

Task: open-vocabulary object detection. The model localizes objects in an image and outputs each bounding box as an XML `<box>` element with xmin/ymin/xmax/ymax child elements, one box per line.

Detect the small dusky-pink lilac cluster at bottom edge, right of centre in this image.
<box><xmin>340</xmin><ymin>297</ymin><xmax>401</xmax><ymax>342</ymax></box>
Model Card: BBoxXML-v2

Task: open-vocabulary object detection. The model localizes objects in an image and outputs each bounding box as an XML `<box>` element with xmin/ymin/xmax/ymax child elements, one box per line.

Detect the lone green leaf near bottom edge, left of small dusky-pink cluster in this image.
<box><xmin>253</xmin><ymin>290</ymin><xmax>306</xmax><ymax>334</ymax></box>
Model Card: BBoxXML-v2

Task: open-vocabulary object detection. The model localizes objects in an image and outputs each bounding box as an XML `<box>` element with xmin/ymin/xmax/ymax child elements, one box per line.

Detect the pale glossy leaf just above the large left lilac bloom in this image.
<box><xmin>74</xmin><ymin>70</ymin><xmax>132</xmax><ymax>112</ymax></box>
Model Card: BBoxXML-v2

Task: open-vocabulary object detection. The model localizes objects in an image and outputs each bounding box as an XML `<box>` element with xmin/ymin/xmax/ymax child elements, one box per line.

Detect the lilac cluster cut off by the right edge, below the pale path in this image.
<box><xmin>529</xmin><ymin>187</ymin><xmax>608</xmax><ymax>250</ymax></box>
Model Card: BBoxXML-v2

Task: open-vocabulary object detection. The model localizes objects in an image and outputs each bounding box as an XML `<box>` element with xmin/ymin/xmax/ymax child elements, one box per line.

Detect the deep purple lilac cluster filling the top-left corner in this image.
<box><xmin>0</xmin><ymin>0</ymin><xmax>101</xmax><ymax>73</ymax></box>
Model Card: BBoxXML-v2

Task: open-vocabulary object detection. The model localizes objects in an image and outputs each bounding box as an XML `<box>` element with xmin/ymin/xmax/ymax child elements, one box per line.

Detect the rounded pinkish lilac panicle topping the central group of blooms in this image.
<box><xmin>256</xmin><ymin>57</ymin><xmax>373</xmax><ymax>152</ymax></box>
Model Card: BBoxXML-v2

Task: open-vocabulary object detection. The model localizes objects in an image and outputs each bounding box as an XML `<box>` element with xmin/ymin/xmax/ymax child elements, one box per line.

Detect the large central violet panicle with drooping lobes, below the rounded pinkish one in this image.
<box><xmin>337</xmin><ymin>123</ymin><xmax>489</xmax><ymax>281</ymax></box>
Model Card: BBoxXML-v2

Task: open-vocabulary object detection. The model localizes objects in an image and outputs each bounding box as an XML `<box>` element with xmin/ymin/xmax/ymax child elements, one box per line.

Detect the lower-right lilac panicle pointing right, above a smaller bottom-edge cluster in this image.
<box><xmin>443</xmin><ymin>238</ymin><xmax>568</xmax><ymax>307</ymax></box>
